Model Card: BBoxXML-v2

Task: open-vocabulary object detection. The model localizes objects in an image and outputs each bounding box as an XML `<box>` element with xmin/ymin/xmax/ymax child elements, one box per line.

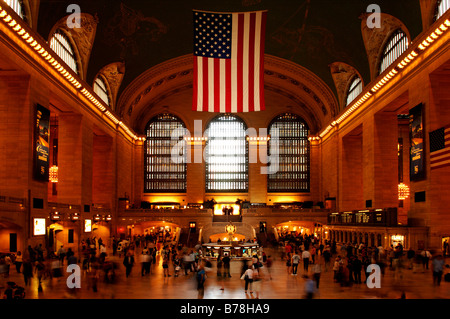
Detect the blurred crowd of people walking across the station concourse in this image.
<box><xmin>0</xmin><ymin>235</ymin><xmax>450</xmax><ymax>298</ymax></box>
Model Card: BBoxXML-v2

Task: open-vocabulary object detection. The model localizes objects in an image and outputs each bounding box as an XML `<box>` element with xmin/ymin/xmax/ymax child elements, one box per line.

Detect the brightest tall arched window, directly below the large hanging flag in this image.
<box><xmin>205</xmin><ymin>115</ymin><xmax>248</xmax><ymax>193</ymax></box>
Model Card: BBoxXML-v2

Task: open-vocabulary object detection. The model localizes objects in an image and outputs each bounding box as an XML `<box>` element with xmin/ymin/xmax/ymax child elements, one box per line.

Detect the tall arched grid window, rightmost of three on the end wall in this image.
<box><xmin>267</xmin><ymin>113</ymin><xmax>310</xmax><ymax>193</ymax></box>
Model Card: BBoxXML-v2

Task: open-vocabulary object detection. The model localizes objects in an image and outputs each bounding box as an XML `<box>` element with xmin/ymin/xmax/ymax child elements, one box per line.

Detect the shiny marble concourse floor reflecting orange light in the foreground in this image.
<box><xmin>3</xmin><ymin>248</ymin><xmax>450</xmax><ymax>300</ymax></box>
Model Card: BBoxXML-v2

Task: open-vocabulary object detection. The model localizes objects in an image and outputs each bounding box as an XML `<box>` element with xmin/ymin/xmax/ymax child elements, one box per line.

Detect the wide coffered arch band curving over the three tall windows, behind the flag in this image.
<box><xmin>117</xmin><ymin>55</ymin><xmax>339</xmax><ymax>131</ymax></box>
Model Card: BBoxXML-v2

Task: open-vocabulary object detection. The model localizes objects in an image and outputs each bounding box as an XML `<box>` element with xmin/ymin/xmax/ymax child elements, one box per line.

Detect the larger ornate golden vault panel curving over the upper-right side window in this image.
<box><xmin>360</xmin><ymin>13</ymin><xmax>411</xmax><ymax>80</ymax></box>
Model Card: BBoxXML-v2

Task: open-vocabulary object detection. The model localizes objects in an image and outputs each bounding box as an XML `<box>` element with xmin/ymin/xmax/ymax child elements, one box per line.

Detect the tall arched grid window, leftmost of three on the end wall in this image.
<box><xmin>144</xmin><ymin>114</ymin><xmax>187</xmax><ymax>193</ymax></box>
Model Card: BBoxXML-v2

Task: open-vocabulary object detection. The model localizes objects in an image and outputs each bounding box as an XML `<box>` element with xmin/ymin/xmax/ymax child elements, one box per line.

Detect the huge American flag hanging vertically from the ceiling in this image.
<box><xmin>192</xmin><ymin>11</ymin><xmax>267</xmax><ymax>113</ymax></box>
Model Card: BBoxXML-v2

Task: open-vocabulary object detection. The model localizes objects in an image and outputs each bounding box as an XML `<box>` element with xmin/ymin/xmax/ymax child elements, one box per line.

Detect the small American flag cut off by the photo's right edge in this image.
<box><xmin>430</xmin><ymin>125</ymin><xmax>450</xmax><ymax>170</ymax></box>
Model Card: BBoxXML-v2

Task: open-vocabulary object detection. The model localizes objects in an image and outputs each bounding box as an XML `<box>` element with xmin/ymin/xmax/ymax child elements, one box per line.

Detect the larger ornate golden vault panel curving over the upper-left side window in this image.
<box><xmin>48</xmin><ymin>13</ymin><xmax>98</xmax><ymax>80</ymax></box>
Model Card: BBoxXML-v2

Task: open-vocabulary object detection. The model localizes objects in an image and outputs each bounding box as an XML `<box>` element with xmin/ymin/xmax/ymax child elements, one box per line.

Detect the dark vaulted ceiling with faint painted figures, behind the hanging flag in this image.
<box><xmin>37</xmin><ymin>0</ymin><xmax>422</xmax><ymax>101</ymax></box>
